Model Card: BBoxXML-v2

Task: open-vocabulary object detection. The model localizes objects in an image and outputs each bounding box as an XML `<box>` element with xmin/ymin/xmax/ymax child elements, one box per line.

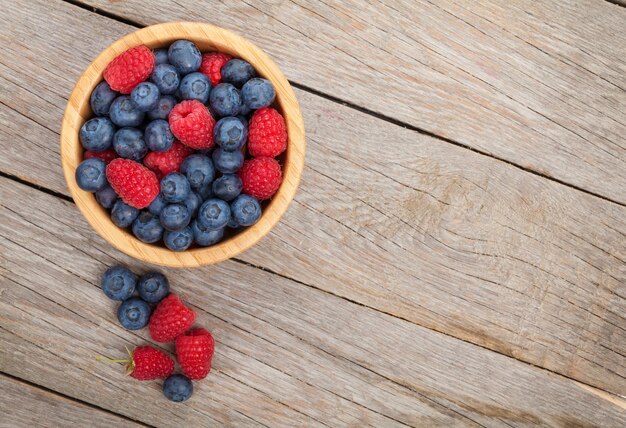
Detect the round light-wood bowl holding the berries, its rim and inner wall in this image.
<box><xmin>61</xmin><ymin>22</ymin><xmax>305</xmax><ymax>267</ymax></box>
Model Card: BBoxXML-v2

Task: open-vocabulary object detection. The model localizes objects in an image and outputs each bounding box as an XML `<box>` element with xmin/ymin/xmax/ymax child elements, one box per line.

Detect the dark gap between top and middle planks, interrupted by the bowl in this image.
<box><xmin>63</xmin><ymin>0</ymin><xmax>626</xmax><ymax>207</ymax></box>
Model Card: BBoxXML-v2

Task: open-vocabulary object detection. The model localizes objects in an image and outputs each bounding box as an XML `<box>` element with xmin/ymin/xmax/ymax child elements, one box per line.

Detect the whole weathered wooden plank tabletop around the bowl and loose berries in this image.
<box><xmin>0</xmin><ymin>0</ymin><xmax>626</xmax><ymax>427</ymax></box>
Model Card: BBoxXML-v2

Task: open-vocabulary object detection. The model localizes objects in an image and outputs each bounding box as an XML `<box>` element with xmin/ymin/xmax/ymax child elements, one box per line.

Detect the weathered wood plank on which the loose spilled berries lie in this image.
<box><xmin>0</xmin><ymin>178</ymin><xmax>626</xmax><ymax>426</ymax></box>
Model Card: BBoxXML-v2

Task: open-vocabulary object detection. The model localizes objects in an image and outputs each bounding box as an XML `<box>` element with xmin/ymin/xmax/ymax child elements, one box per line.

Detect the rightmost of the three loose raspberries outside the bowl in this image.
<box><xmin>176</xmin><ymin>328</ymin><xmax>215</xmax><ymax>380</ymax></box>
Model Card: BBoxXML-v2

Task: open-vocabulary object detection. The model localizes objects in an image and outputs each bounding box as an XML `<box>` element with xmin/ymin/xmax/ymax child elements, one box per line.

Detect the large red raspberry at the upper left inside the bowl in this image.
<box><xmin>104</xmin><ymin>45</ymin><xmax>154</xmax><ymax>94</ymax></box>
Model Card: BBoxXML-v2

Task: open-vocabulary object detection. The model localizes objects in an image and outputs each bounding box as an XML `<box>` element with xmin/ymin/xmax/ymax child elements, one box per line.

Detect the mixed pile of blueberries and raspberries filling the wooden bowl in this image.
<box><xmin>62</xmin><ymin>24</ymin><xmax>304</xmax><ymax>265</ymax></box>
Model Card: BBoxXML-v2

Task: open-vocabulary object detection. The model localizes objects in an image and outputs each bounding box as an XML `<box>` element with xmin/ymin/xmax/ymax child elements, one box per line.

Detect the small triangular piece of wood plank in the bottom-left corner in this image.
<box><xmin>0</xmin><ymin>374</ymin><xmax>142</xmax><ymax>428</ymax></box>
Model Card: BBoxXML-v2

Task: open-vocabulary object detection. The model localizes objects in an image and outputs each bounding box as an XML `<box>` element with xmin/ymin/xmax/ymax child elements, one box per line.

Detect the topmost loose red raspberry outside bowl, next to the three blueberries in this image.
<box><xmin>148</xmin><ymin>294</ymin><xmax>196</xmax><ymax>342</ymax></box>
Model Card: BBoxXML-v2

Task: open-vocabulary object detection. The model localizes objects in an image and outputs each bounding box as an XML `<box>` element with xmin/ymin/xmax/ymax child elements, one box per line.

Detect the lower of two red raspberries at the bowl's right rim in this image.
<box><xmin>239</xmin><ymin>157</ymin><xmax>282</xmax><ymax>199</ymax></box>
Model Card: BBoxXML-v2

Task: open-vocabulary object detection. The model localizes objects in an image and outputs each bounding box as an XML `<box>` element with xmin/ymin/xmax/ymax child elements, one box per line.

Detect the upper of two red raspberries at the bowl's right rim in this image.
<box><xmin>248</xmin><ymin>107</ymin><xmax>287</xmax><ymax>158</ymax></box>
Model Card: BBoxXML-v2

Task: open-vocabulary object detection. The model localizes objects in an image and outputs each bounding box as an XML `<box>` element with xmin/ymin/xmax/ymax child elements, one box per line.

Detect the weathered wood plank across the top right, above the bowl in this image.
<box><xmin>68</xmin><ymin>0</ymin><xmax>626</xmax><ymax>204</ymax></box>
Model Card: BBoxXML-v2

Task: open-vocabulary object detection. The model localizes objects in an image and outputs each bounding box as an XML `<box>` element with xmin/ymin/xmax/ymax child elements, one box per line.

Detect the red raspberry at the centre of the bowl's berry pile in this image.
<box><xmin>169</xmin><ymin>100</ymin><xmax>215</xmax><ymax>150</ymax></box>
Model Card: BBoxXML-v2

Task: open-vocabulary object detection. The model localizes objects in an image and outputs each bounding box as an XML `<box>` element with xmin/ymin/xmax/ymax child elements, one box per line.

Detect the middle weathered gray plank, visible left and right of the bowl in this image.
<box><xmin>0</xmin><ymin>3</ymin><xmax>626</xmax><ymax>393</ymax></box>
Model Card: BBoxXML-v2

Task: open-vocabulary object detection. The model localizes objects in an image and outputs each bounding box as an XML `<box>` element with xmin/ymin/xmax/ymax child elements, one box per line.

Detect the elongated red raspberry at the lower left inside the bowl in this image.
<box><xmin>107</xmin><ymin>158</ymin><xmax>160</xmax><ymax>209</ymax></box>
